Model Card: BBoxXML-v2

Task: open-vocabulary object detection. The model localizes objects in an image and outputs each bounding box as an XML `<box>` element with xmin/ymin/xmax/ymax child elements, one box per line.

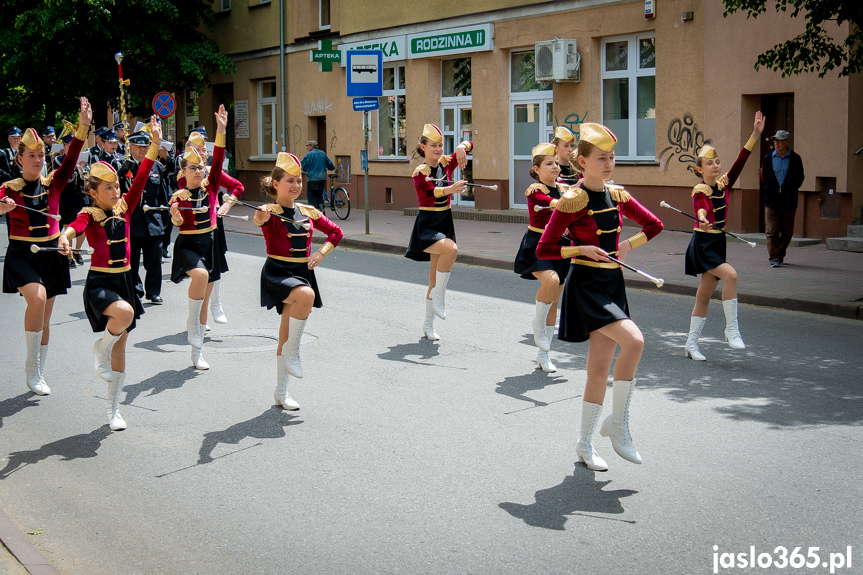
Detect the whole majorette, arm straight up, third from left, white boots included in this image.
<box><xmin>171</xmin><ymin>105</ymin><xmax>228</xmax><ymax>369</ymax></box>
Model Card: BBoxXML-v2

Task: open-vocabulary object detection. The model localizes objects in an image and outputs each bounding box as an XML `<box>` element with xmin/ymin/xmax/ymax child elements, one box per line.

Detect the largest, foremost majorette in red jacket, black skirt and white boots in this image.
<box><xmin>536</xmin><ymin>123</ymin><xmax>662</xmax><ymax>471</ymax></box>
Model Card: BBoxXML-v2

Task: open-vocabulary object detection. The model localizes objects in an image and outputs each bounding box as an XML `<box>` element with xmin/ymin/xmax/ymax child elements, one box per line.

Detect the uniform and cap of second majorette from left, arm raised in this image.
<box><xmin>66</xmin><ymin>148</ymin><xmax>159</xmax><ymax>335</ymax></box>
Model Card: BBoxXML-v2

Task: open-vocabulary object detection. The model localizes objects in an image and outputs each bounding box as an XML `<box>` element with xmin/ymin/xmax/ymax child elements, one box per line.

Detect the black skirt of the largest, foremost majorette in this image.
<box><xmin>557</xmin><ymin>264</ymin><xmax>629</xmax><ymax>342</ymax></box>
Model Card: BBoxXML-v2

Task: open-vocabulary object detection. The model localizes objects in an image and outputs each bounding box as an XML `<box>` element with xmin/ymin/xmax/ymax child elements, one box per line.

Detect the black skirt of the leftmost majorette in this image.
<box><xmin>3</xmin><ymin>238</ymin><xmax>72</xmax><ymax>299</ymax></box>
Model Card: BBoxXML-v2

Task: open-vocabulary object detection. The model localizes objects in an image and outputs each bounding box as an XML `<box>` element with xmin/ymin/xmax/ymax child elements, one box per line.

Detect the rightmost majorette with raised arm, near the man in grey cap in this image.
<box><xmin>683</xmin><ymin>112</ymin><xmax>764</xmax><ymax>361</ymax></box>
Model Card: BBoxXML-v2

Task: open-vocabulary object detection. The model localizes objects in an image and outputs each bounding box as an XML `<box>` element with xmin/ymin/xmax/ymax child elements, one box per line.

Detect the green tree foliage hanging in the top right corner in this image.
<box><xmin>723</xmin><ymin>0</ymin><xmax>863</xmax><ymax>78</ymax></box>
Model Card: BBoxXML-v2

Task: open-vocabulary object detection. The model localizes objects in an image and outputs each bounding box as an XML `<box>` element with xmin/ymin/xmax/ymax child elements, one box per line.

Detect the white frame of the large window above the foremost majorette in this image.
<box><xmin>600</xmin><ymin>31</ymin><xmax>656</xmax><ymax>163</ymax></box>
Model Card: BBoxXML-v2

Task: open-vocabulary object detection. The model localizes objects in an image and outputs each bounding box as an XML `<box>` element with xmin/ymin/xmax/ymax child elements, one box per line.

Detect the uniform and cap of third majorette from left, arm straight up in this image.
<box><xmin>171</xmin><ymin>133</ymin><xmax>225</xmax><ymax>283</ymax></box>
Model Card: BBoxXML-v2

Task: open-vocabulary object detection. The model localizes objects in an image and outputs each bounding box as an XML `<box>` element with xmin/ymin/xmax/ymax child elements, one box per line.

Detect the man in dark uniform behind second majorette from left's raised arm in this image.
<box><xmin>118</xmin><ymin>130</ymin><xmax>171</xmax><ymax>305</ymax></box>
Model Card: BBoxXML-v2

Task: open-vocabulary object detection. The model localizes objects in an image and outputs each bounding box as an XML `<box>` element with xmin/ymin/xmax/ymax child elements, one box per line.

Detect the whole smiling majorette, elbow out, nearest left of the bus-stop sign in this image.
<box><xmin>255</xmin><ymin>152</ymin><xmax>343</xmax><ymax>411</ymax></box>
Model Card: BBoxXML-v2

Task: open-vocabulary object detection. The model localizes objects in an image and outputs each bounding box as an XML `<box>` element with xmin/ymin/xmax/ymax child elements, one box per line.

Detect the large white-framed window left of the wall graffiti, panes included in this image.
<box><xmin>602</xmin><ymin>34</ymin><xmax>656</xmax><ymax>160</ymax></box>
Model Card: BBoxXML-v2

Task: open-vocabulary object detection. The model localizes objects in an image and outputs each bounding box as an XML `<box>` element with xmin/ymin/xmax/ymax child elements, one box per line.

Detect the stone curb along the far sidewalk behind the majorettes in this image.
<box><xmin>225</xmin><ymin>227</ymin><xmax>863</xmax><ymax>320</ymax></box>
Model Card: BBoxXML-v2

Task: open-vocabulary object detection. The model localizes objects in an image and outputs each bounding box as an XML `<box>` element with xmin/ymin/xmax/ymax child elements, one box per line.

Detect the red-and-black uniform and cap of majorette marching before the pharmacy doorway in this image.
<box><xmin>405</xmin><ymin>124</ymin><xmax>473</xmax><ymax>262</ymax></box>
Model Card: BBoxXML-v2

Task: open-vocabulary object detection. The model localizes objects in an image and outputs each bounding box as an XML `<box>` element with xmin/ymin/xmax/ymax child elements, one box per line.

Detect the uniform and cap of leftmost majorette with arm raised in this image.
<box><xmin>0</xmin><ymin>125</ymin><xmax>90</xmax><ymax>299</ymax></box>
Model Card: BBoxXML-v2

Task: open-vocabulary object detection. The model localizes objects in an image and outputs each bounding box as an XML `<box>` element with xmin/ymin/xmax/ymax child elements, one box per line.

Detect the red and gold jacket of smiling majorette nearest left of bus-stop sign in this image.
<box><xmin>256</xmin><ymin>203</ymin><xmax>344</xmax><ymax>263</ymax></box>
